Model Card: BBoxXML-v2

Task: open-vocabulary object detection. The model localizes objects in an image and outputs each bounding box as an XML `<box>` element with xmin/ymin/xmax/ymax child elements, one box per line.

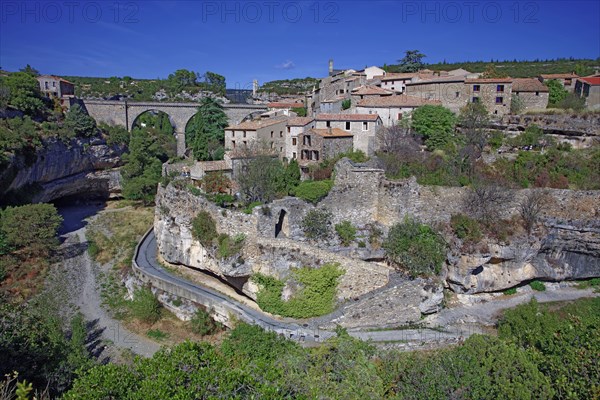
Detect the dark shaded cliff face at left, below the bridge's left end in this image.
<box><xmin>0</xmin><ymin>138</ymin><xmax>125</xmax><ymax>203</ymax></box>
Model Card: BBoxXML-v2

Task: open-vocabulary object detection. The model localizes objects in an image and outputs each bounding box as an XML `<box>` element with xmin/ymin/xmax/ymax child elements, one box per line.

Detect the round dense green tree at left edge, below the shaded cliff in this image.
<box><xmin>0</xmin><ymin>204</ymin><xmax>62</xmax><ymax>256</ymax></box>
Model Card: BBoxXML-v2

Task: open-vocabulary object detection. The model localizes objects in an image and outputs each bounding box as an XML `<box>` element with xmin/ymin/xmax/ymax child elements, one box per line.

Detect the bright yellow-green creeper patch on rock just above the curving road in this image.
<box><xmin>251</xmin><ymin>264</ymin><xmax>344</xmax><ymax>318</ymax></box>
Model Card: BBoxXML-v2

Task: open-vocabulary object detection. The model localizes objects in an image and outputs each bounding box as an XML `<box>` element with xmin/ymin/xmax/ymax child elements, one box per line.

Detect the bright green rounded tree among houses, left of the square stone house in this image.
<box><xmin>412</xmin><ymin>105</ymin><xmax>456</xmax><ymax>150</ymax></box>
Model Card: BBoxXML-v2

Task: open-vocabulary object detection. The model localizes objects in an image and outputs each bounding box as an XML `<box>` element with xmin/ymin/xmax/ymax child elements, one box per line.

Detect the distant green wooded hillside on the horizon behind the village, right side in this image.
<box><xmin>384</xmin><ymin>58</ymin><xmax>600</xmax><ymax>78</ymax></box>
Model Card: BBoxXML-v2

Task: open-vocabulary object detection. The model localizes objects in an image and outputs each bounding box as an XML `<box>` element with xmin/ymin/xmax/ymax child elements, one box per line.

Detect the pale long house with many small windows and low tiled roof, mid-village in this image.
<box><xmin>315</xmin><ymin>114</ymin><xmax>383</xmax><ymax>156</ymax></box>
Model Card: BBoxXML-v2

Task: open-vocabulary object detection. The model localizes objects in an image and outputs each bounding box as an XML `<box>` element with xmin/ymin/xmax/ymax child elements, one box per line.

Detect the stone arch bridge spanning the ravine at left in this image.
<box><xmin>79</xmin><ymin>100</ymin><xmax>267</xmax><ymax>156</ymax></box>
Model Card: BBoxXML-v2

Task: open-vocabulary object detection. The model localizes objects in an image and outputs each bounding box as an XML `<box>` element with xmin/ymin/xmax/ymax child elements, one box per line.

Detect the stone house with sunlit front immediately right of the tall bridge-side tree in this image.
<box><xmin>225</xmin><ymin>117</ymin><xmax>288</xmax><ymax>157</ymax></box>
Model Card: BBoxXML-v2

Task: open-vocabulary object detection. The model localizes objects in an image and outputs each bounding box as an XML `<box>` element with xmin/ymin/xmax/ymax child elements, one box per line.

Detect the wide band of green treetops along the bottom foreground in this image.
<box><xmin>52</xmin><ymin>298</ymin><xmax>600</xmax><ymax>400</ymax></box>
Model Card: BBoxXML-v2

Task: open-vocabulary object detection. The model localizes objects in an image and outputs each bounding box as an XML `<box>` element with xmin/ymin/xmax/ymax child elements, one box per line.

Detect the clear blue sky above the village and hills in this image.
<box><xmin>0</xmin><ymin>0</ymin><xmax>600</xmax><ymax>88</ymax></box>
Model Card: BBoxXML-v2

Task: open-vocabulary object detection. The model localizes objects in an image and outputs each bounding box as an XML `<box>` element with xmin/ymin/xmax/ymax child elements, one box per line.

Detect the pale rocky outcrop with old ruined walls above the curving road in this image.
<box><xmin>154</xmin><ymin>184</ymin><xmax>390</xmax><ymax>299</ymax></box>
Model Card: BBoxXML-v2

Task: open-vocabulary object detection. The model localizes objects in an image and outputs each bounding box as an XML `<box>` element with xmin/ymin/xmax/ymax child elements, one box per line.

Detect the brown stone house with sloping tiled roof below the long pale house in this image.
<box><xmin>298</xmin><ymin>128</ymin><xmax>353</xmax><ymax>173</ymax></box>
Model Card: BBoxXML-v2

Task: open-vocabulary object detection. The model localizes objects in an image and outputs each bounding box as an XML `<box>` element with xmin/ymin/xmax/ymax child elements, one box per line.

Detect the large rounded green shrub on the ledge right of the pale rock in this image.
<box><xmin>383</xmin><ymin>217</ymin><xmax>446</xmax><ymax>276</ymax></box>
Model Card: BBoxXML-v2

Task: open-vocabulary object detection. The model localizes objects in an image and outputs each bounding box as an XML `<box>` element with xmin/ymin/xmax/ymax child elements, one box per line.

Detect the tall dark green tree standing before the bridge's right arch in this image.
<box><xmin>185</xmin><ymin>97</ymin><xmax>228</xmax><ymax>161</ymax></box>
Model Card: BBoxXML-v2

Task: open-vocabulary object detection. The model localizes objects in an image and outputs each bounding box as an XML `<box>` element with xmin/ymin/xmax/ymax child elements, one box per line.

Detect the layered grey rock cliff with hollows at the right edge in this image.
<box><xmin>446</xmin><ymin>220</ymin><xmax>600</xmax><ymax>294</ymax></box>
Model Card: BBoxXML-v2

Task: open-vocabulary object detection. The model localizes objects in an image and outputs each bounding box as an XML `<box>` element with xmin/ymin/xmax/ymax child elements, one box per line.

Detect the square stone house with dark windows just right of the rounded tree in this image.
<box><xmin>465</xmin><ymin>78</ymin><xmax>513</xmax><ymax>116</ymax></box>
